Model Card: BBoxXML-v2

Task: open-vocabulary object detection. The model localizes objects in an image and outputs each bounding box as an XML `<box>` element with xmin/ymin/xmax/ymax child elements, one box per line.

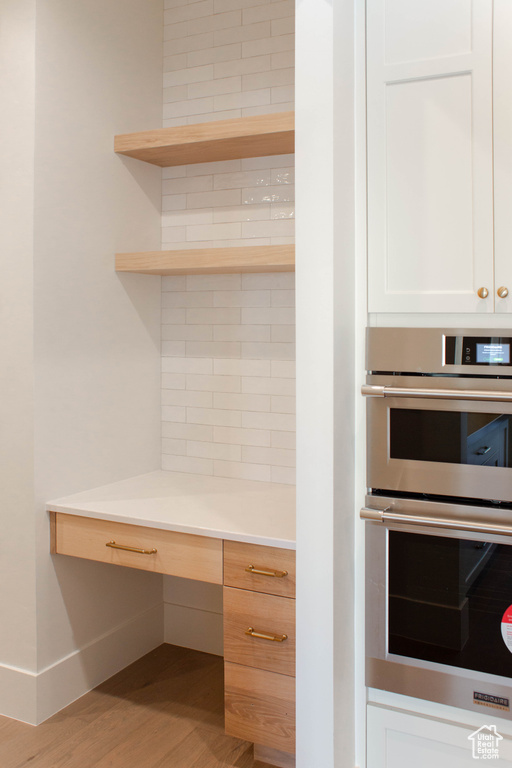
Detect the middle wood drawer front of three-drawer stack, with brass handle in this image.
<box><xmin>223</xmin><ymin>587</ymin><xmax>295</xmax><ymax>676</ymax></box>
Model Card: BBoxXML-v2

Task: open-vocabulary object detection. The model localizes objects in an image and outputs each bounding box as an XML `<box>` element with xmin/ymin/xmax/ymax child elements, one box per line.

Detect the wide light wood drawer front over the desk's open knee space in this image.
<box><xmin>55</xmin><ymin>512</ymin><xmax>222</xmax><ymax>584</ymax></box>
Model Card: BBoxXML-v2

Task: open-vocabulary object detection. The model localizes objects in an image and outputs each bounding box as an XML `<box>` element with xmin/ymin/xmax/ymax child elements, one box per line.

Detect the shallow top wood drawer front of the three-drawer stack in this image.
<box><xmin>224</xmin><ymin>541</ymin><xmax>295</xmax><ymax>597</ymax></box>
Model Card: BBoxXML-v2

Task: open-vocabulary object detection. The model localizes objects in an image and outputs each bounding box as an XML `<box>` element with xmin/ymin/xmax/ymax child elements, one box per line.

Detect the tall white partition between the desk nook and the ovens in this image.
<box><xmin>295</xmin><ymin>0</ymin><xmax>355</xmax><ymax>768</ymax></box>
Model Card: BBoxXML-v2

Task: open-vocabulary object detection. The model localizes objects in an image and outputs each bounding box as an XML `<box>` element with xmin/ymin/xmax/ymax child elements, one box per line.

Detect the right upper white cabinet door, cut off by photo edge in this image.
<box><xmin>493</xmin><ymin>0</ymin><xmax>512</xmax><ymax>312</ymax></box>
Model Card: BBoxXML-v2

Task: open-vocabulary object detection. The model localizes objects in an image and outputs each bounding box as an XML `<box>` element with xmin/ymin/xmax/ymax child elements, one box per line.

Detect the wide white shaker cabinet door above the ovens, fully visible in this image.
<box><xmin>367</xmin><ymin>0</ymin><xmax>496</xmax><ymax>312</ymax></box>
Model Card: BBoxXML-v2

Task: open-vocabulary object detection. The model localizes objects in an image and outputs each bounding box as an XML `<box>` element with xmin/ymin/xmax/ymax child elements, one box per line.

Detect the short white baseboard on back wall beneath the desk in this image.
<box><xmin>164</xmin><ymin>603</ymin><xmax>223</xmax><ymax>656</ymax></box>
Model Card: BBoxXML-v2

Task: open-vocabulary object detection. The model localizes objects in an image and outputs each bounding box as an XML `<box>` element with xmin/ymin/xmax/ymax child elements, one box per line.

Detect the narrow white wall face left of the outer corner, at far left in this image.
<box><xmin>0</xmin><ymin>0</ymin><xmax>36</xmax><ymax>716</ymax></box>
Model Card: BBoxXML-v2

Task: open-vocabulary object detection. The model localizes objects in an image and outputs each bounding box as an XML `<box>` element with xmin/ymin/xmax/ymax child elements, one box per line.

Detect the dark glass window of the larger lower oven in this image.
<box><xmin>387</xmin><ymin>530</ymin><xmax>512</xmax><ymax>678</ymax></box>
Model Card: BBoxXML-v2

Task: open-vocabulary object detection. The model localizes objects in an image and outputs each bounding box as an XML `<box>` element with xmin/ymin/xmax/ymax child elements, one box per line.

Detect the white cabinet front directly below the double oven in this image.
<box><xmin>366</xmin><ymin>704</ymin><xmax>512</xmax><ymax>768</ymax></box>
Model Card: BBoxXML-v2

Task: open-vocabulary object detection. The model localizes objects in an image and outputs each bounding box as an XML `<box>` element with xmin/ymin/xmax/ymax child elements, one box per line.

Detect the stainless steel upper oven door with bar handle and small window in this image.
<box><xmin>363</xmin><ymin>376</ymin><xmax>512</xmax><ymax>501</ymax></box>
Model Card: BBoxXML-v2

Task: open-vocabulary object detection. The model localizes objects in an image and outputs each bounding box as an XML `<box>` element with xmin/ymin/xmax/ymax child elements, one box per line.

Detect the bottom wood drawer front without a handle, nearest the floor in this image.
<box><xmin>224</xmin><ymin>662</ymin><xmax>295</xmax><ymax>753</ymax></box>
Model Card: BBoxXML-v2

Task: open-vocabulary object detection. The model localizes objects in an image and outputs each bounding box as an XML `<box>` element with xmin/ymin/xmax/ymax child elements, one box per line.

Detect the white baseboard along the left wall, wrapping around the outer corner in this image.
<box><xmin>0</xmin><ymin>603</ymin><xmax>164</xmax><ymax>725</ymax></box>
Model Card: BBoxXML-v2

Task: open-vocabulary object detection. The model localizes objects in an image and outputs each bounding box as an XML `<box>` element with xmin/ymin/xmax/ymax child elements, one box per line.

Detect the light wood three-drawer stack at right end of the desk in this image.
<box><xmin>223</xmin><ymin>541</ymin><xmax>295</xmax><ymax>765</ymax></box>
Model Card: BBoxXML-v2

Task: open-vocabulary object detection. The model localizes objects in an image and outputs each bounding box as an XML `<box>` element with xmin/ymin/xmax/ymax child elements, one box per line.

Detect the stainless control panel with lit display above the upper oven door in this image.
<box><xmin>366</xmin><ymin>328</ymin><xmax>512</xmax><ymax>378</ymax></box>
